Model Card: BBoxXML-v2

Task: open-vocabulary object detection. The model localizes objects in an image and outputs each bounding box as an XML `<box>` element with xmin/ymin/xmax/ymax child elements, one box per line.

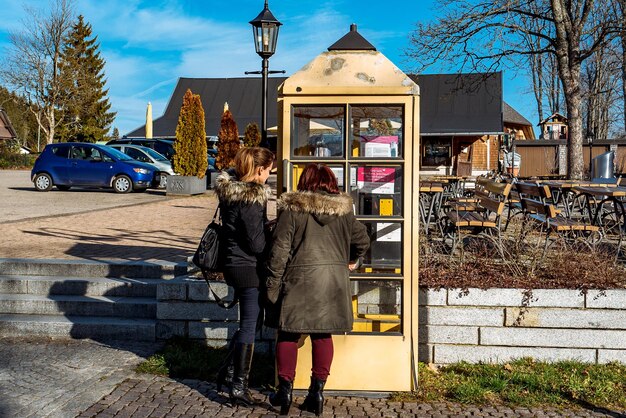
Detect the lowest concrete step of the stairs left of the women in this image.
<box><xmin>0</xmin><ymin>314</ymin><xmax>156</xmax><ymax>341</ymax></box>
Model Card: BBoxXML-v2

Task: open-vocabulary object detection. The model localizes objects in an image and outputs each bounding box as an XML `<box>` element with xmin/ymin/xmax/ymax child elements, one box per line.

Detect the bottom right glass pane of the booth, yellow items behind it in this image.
<box><xmin>351</xmin><ymin>280</ymin><xmax>402</xmax><ymax>332</ymax></box>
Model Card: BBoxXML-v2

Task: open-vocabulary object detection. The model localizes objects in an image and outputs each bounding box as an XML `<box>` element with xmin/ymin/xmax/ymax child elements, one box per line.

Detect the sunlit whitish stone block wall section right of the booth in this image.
<box><xmin>419</xmin><ymin>289</ymin><xmax>626</xmax><ymax>364</ymax></box>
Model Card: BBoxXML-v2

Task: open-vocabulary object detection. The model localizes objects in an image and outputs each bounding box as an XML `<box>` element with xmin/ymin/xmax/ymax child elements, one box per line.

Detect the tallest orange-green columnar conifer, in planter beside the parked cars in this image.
<box><xmin>172</xmin><ymin>89</ymin><xmax>208</xmax><ymax>178</ymax></box>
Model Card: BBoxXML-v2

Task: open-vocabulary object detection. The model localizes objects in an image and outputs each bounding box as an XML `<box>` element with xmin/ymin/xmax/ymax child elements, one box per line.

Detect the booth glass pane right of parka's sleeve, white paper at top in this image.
<box><xmin>355</xmin><ymin>220</ymin><xmax>402</xmax><ymax>274</ymax></box>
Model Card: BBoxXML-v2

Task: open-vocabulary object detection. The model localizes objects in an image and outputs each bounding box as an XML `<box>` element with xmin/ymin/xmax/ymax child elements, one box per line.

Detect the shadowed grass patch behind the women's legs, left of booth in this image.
<box><xmin>135</xmin><ymin>338</ymin><xmax>274</xmax><ymax>387</ymax></box>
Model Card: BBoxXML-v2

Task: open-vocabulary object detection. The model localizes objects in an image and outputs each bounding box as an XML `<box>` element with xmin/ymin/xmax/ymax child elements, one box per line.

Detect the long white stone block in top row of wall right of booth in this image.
<box><xmin>448</xmin><ymin>289</ymin><xmax>585</xmax><ymax>308</ymax></box>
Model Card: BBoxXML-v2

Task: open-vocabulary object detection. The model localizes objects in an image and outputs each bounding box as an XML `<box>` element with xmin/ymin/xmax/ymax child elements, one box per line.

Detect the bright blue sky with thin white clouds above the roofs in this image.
<box><xmin>0</xmin><ymin>0</ymin><xmax>537</xmax><ymax>134</ymax></box>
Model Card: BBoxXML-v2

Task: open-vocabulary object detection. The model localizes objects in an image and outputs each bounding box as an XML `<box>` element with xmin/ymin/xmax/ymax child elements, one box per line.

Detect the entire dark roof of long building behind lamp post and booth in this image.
<box><xmin>127</xmin><ymin>73</ymin><xmax>531</xmax><ymax>138</ymax></box>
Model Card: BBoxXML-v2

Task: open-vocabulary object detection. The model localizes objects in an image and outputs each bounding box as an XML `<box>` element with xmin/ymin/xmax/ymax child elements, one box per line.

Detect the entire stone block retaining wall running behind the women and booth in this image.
<box><xmin>156</xmin><ymin>278</ymin><xmax>626</xmax><ymax>364</ymax></box>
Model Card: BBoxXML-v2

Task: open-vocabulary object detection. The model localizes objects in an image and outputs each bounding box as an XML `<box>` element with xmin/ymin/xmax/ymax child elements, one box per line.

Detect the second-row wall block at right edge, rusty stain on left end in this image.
<box><xmin>506</xmin><ymin>308</ymin><xmax>626</xmax><ymax>330</ymax></box>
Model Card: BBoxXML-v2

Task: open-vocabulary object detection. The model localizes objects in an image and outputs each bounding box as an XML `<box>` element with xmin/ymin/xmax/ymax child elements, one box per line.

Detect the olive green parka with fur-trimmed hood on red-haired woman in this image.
<box><xmin>266</xmin><ymin>192</ymin><xmax>370</xmax><ymax>334</ymax></box>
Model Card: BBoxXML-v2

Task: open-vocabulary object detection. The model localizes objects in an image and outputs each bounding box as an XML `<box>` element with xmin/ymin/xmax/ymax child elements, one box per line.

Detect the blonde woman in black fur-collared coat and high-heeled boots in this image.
<box><xmin>215</xmin><ymin>147</ymin><xmax>274</xmax><ymax>405</ymax></box>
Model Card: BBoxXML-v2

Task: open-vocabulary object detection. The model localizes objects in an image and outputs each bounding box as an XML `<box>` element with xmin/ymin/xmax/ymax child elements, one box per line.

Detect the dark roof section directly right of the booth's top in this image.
<box><xmin>409</xmin><ymin>72</ymin><xmax>504</xmax><ymax>135</ymax></box>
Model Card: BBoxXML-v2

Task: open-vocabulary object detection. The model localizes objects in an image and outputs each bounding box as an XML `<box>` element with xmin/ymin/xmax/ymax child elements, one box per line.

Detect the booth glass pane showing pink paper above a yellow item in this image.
<box><xmin>350</xmin><ymin>165</ymin><xmax>402</xmax><ymax>216</ymax></box>
